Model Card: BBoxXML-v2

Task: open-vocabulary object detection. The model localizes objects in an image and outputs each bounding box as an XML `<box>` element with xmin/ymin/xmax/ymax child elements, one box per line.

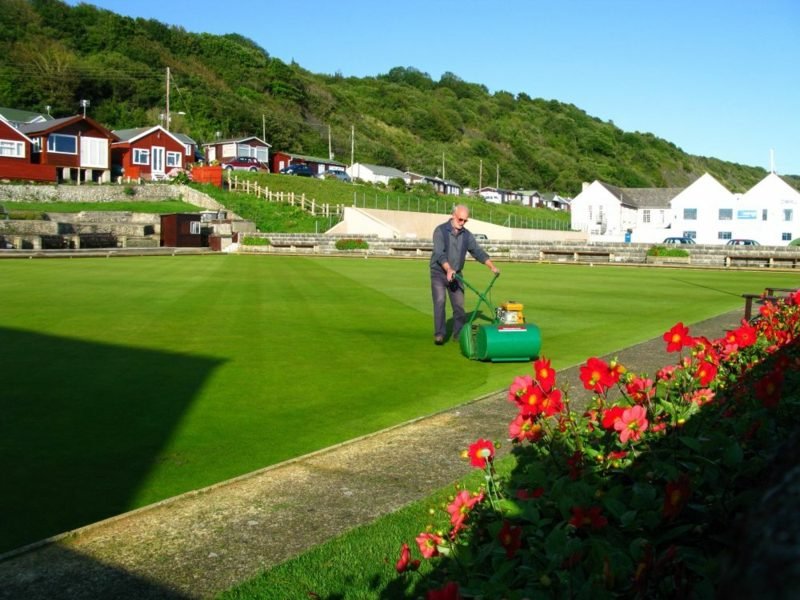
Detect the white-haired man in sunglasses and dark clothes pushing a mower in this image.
<box><xmin>430</xmin><ymin>204</ymin><xmax>500</xmax><ymax>346</ymax></box>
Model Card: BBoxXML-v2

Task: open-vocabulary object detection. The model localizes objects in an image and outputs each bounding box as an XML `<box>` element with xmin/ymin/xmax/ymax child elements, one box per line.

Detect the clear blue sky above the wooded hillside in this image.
<box><xmin>68</xmin><ymin>0</ymin><xmax>800</xmax><ymax>175</ymax></box>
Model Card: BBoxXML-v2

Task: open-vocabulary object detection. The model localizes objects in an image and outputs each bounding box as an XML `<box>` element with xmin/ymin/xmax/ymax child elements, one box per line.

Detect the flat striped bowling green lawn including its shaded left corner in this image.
<box><xmin>0</xmin><ymin>255</ymin><xmax>796</xmax><ymax>551</ymax></box>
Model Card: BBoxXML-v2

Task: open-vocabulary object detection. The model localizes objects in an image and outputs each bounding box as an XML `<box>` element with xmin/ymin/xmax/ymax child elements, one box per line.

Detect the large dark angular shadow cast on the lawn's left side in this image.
<box><xmin>0</xmin><ymin>328</ymin><xmax>221</xmax><ymax>553</ymax></box>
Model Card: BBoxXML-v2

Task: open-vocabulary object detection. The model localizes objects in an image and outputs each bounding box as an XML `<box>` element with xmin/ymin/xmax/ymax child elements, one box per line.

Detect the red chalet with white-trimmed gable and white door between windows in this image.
<box><xmin>111</xmin><ymin>125</ymin><xmax>191</xmax><ymax>180</ymax></box>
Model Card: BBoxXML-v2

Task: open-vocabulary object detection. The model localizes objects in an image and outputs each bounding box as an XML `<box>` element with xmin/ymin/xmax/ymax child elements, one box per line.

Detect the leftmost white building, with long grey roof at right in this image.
<box><xmin>570</xmin><ymin>180</ymin><xmax>682</xmax><ymax>241</ymax></box>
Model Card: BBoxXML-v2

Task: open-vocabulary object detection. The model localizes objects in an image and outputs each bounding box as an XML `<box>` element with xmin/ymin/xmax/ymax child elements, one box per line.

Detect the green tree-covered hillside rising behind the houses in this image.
<box><xmin>0</xmin><ymin>0</ymin><xmax>780</xmax><ymax>195</ymax></box>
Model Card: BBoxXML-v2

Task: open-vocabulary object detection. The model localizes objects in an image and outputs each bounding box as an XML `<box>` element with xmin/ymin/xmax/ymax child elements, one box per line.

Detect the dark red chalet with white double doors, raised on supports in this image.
<box><xmin>19</xmin><ymin>115</ymin><xmax>117</xmax><ymax>183</ymax></box>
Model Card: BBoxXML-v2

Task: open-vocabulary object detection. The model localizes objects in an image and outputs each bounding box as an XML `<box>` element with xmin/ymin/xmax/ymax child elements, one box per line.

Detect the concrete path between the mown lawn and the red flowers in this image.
<box><xmin>0</xmin><ymin>311</ymin><xmax>742</xmax><ymax>600</ymax></box>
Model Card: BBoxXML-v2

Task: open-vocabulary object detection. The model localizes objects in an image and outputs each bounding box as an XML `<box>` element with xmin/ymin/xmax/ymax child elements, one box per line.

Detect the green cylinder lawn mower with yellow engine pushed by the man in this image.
<box><xmin>456</xmin><ymin>273</ymin><xmax>542</xmax><ymax>362</ymax></box>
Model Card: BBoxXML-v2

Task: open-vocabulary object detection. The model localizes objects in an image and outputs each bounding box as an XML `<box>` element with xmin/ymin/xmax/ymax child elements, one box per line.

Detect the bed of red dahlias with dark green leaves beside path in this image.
<box><xmin>396</xmin><ymin>293</ymin><xmax>800</xmax><ymax>599</ymax></box>
